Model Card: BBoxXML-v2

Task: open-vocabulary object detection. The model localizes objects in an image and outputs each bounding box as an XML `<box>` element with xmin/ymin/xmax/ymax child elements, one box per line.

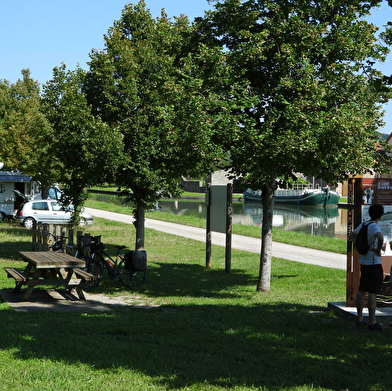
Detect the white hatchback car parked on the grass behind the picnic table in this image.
<box><xmin>15</xmin><ymin>200</ymin><xmax>93</xmax><ymax>228</ymax></box>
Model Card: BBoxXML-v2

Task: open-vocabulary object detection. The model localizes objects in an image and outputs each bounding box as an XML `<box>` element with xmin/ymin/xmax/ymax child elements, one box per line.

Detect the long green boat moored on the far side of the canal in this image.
<box><xmin>244</xmin><ymin>187</ymin><xmax>340</xmax><ymax>206</ymax></box>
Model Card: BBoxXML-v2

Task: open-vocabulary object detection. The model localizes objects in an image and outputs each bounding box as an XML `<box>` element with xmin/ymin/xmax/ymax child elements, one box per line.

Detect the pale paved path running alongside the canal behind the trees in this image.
<box><xmin>85</xmin><ymin>208</ymin><xmax>346</xmax><ymax>270</ymax></box>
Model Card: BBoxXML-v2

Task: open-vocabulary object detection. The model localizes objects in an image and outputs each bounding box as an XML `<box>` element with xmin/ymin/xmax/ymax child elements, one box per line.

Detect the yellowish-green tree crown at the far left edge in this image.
<box><xmin>0</xmin><ymin>70</ymin><xmax>58</xmax><ymax>190</ymax></box>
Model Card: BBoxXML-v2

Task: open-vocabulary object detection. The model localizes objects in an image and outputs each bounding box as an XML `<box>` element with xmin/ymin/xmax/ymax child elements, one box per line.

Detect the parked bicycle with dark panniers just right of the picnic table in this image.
<box><xmin>82</xmin><ymin>236</ymin><xmax>147</xmax><ymax>288</ymax></box>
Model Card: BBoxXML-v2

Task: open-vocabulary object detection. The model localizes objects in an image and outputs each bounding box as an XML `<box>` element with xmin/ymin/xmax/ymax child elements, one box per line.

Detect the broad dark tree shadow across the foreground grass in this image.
<box><xmin>0</xmin><ymin>303</ymin><xmax>391</xmax><ymax>391</ymax></box>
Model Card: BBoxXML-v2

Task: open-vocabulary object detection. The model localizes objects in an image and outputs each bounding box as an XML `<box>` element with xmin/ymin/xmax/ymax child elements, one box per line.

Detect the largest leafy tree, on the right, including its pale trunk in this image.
<box><xmin>198</xmin><ymin>0</ymin><xmax>389</xmax><ymax>291</ymax></box>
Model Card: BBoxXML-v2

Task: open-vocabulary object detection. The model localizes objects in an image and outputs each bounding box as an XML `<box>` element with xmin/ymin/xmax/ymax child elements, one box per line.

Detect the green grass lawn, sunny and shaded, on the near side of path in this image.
<box><xmin>0</xmin><ymin>214</ymin><xmax>392</xmax><ymax>391</ymax></box>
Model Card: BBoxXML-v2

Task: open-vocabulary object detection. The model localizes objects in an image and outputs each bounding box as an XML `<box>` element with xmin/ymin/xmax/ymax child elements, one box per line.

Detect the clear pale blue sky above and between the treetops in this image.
<box><xmin>0</xmin><ymin>0</ymin><xmax>392</xmax><ymax>134</ymax></box>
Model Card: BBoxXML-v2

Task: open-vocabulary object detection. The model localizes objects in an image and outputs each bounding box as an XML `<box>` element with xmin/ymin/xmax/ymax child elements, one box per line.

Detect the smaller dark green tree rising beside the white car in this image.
<box><xmin>42</xmin><ymin>64</ymin><xmax>123</xmax><ymax>223</ymax></box>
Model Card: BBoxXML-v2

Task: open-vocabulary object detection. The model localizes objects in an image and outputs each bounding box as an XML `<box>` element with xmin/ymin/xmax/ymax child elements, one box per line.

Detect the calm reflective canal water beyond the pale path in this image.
<box><xmin>90</xmin><ymin>194</ymin><xmax>347</xmax><ymax>239</ymax></box>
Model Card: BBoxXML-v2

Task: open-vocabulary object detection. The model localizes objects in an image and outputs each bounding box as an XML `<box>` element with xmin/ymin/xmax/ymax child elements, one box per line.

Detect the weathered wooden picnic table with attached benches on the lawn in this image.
<box><xmin>5</xmin><ymin>251</ymin><xmax>95</xmax><ymax>300</ymax></box>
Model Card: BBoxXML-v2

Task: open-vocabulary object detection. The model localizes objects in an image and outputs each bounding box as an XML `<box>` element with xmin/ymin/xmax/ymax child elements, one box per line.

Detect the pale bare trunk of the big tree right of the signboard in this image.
<box><xmin>257</xmin><ymin>179</ymin><xmax>276</xmax><ymax>292</ymax></box>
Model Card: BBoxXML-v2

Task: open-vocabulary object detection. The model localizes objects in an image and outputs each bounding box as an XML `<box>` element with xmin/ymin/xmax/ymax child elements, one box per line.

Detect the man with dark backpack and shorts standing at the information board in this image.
<box><xmin>352</xmin><ymin>204</ymin><xmax>384</xmax><ymax>331</ymax></box>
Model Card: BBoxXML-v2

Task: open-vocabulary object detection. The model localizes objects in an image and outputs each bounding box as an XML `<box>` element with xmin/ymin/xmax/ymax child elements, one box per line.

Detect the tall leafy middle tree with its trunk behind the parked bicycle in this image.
<box><xmin>85</xmin><ymin>1</ymin><xmax>234</xmax><ymax>249</ymax></box>
